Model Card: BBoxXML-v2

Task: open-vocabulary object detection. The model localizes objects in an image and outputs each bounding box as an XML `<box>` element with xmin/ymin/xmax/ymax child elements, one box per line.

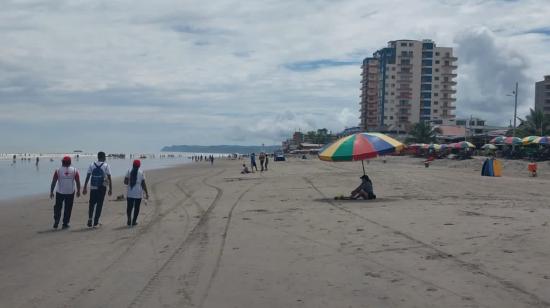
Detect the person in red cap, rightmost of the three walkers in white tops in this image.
<box><xmin>124</xmin><ymin>159</ymin><xmax>149</xmax><ymax>227</ymax></box>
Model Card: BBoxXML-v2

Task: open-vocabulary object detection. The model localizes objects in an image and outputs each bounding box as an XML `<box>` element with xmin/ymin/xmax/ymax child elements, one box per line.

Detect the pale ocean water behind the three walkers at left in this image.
<box><xmin>0</xmin><ymin>153</ymin><xmax>201</xmax><ymax>201</ymax></box>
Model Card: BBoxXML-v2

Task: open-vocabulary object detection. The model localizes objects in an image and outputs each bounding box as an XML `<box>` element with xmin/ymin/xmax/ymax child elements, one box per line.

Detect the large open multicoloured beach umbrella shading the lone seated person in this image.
<box><xmin>319</xmin><ymin>133</ymin><xmax>405</xmax><ymax>173</ymax></box>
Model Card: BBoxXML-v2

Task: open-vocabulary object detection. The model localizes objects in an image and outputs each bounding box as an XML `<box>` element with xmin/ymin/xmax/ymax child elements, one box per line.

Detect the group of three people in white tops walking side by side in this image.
<box><xmin>50</xmin><ymin>152</ymin><xmax>149</xmax><ymax>229</ymax></box>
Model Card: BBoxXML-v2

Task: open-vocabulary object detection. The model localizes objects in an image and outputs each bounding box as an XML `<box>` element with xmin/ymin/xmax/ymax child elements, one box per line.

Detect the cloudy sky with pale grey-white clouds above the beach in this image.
<box><xmin>0</xmin><ymin>0</ymin><xmax>550</xmax><ymax>152</ymax></box>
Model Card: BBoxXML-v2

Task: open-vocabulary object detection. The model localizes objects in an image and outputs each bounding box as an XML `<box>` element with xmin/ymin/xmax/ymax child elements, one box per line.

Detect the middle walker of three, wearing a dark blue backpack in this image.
<box><xmin>82</xmin><ymin>152</ymin><xmax>113</xmax><ymax>227</ymax></box>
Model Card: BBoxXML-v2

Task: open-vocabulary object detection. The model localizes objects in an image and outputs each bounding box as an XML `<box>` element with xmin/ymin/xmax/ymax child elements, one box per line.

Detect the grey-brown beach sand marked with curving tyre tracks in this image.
<box><xmin>0</xmin><ymin>157</ymin><xmax>550</xmax><ymax>307</ymax></box>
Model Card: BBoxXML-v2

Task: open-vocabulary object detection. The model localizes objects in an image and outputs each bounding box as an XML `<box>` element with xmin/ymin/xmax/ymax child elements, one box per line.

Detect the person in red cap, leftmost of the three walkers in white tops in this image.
<box><xmin>50</xmin><ymin>156</ymin><xmax>80</xmax><ymax>229</ymax></box>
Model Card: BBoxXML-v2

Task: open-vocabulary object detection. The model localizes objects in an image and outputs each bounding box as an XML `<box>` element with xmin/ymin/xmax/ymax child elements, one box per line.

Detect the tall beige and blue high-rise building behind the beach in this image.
<box><xmin>360</xmin><ymin>40</ymin><xmax>457</xmax><ymax>134</ymax></box>
